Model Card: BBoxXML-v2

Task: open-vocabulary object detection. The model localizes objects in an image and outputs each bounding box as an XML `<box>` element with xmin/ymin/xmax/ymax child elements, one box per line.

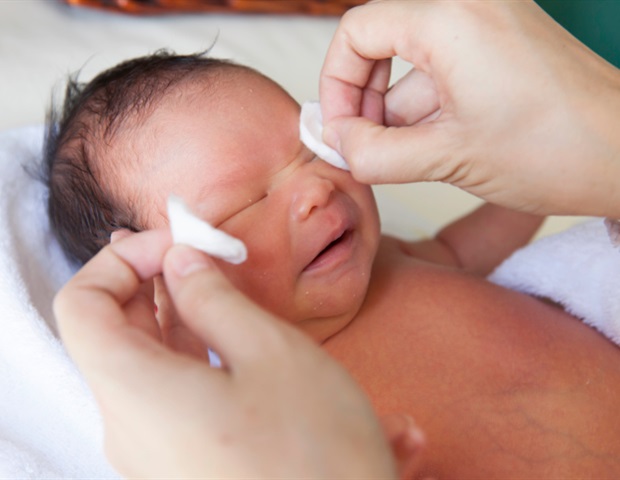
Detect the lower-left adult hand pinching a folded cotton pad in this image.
<box><xmin>54</xmin><ymin>230</ymin><xmax>420</xmax><ymax>478</ymax></box>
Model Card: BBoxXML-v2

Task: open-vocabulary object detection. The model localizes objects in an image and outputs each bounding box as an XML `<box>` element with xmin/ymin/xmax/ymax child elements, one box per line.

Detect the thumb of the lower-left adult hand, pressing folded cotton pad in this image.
<box><xmin>164</xmin><ymin>245</ymin><xmax>301</xmax><ymax>371</ymax></box>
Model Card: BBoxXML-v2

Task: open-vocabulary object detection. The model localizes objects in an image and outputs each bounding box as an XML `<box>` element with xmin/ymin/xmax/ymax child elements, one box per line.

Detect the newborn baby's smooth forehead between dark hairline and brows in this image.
<box><xmin>126</xmin><ymin>71</ymin><xmax>312</xmax><ymax>223</ymax></box>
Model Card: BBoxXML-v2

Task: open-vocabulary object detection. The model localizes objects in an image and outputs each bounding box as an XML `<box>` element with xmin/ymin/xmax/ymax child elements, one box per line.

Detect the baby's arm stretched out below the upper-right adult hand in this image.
<box><xmin>404</xmin><ymin>203</ymin><xmax>544</xmax><ymax>276</ymax></box>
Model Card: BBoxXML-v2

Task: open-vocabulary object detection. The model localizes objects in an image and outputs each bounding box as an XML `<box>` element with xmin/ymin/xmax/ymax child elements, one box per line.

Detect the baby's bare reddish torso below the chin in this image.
<box><xmin>324</xmin><ymin>238</ymin><xmax>620</xmax><ymax>479</ymax></box>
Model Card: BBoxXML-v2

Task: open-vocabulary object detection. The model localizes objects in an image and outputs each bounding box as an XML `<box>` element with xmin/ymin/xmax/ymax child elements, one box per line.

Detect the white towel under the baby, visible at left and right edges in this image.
<box><xmin>0</xmin><ymin>127</ymin><xmax>620</xmax><ymax>479</ymax></box>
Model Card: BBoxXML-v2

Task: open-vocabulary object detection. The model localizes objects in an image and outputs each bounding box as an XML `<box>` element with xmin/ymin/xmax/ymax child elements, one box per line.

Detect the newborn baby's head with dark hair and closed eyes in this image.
<box><xmin>46</xmin><ymin>53</ymin><xmax>379</xmax><ymax>340</ymax></box>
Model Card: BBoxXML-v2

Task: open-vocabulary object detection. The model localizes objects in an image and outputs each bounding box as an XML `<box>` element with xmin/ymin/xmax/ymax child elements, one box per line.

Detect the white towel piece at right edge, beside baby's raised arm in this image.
<box><xmin>489</xmin><ymin>220</ymin><xmax>620</xmax><ymax>344</ymax></box>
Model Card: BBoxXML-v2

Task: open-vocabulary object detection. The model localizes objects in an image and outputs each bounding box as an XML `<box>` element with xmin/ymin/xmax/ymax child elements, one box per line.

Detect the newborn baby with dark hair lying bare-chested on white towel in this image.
<box><xmin>46</xmin><ymin>52</ymin><xmax>620</xmax><ymax>479</ymax></box>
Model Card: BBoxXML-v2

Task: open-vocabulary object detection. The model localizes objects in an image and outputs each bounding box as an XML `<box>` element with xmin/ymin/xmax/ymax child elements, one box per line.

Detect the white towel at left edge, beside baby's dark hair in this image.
<box><xmin>0</xmin><ymin>127</ymin><xmax>119</xmax><ymax>480</ymax></box>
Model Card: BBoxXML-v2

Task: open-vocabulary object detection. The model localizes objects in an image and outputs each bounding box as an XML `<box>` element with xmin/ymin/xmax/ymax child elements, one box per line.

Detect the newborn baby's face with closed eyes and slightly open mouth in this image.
<box><xmin>123</xmin><ymin>72</ymin><xmax>379</xmax><ymax>341</ymax></box>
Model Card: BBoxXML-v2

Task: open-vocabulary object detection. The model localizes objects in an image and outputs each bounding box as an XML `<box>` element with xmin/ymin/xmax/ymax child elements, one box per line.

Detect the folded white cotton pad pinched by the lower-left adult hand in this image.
<box><xmin>168</xmin><ymin>195</ymin><xmax>248</xmax><ymax>264</ymax></box>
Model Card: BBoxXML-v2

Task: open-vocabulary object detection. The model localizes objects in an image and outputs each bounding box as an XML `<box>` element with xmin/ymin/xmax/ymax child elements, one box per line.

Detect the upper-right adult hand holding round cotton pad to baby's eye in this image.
<box><xmin>320</xmin><ymin>0</ymin><xmax>620</xmax><ymax>218</ymax></box>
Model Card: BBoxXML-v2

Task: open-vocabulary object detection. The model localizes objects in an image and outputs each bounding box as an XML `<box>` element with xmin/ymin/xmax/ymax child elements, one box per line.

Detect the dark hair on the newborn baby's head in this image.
<box><xmin>44</xmin><ymin>50</ymin><xmax>243</xmax><ymax>263</ymax></box>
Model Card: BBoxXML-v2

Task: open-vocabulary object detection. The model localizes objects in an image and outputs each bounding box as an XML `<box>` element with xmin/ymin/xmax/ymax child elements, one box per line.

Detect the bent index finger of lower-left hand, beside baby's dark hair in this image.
<box><xmin>54</xmin><ymin>230</ymin><xmax>171</xmax><ymax>377</ymax></box>
